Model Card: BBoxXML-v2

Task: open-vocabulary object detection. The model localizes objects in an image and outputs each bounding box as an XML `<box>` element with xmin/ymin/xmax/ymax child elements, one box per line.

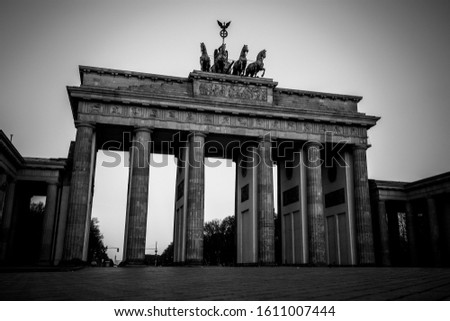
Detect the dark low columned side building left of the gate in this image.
<box><xmin>0</xmin><ymin>130</ymin><xmax>71</xmax><ymax>265</ymax></box>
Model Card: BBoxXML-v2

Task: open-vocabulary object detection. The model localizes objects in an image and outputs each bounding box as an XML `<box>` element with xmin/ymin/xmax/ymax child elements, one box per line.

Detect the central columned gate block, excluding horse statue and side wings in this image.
<box><xmin>61</xmin><ymin>59</ymin><xmax>378</xmax><ymax>265</ymax></box>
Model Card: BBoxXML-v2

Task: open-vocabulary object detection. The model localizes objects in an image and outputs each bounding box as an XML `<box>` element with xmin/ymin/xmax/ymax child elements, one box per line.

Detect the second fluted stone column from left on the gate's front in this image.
<box><xmin>125</xmin><ymin>127</ymin><xmax>152</xmax><ymax>264</ymax></box>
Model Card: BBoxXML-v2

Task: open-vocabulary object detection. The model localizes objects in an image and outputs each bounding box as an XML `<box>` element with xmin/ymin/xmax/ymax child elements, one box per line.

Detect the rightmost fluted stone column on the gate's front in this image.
<box><xmin>353</xmin><ymin>145</ymin><xmax>375</xmax><ymax>265</ymax></box>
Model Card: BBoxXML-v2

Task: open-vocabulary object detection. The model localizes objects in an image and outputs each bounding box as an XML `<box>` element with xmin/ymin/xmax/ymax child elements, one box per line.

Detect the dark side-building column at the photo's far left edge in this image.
<box><xmin>0</xmin><ymin>180</ymin><xmax>16</xmax><ymax>262</ymax></box>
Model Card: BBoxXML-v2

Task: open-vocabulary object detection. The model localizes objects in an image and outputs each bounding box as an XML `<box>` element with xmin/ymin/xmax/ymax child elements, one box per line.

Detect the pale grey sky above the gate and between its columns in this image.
<box><xmin>0</xmin><ymin>0</ymin><xmax>450</xmax><ymax>255</ymax></box>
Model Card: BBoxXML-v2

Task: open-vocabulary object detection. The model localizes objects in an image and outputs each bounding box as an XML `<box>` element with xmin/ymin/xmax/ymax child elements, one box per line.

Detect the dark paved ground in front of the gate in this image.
<box><xmin>0</xmin><ymin>267</ymin><xmax>450</xmax><ymax>301</ymax></box>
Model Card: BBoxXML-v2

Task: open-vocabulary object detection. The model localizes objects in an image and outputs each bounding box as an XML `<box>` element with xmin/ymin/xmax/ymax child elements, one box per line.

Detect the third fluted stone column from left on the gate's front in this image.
<box><xmin>186</xmin><ymin>133</ymin><xmax>206</xmax><ymax>264</ymax></box>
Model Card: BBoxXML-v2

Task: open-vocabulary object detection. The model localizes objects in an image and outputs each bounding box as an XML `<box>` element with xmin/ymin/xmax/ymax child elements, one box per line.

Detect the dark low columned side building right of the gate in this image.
<box><xmin>369</xmin><ymin>172</ymin><xmax>450</xmax><ymax>266</ymax></box>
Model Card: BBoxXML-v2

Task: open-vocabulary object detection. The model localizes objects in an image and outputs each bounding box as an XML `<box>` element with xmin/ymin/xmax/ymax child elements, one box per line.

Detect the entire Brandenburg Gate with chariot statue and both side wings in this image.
<box><xmin>0</xmin><ymin>21</ymin><xmax>450</xmax><ymax>266</ymax></box>
